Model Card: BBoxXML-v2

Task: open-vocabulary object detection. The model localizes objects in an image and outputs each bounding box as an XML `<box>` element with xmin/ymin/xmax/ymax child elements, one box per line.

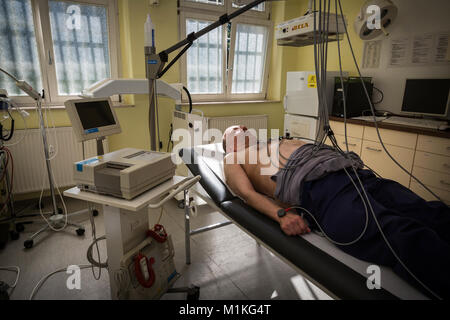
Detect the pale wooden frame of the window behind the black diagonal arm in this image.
<box><xmin>178</xmin><ymin>0</ymin><xmax>274</xmax><ymax>102</ymax></box>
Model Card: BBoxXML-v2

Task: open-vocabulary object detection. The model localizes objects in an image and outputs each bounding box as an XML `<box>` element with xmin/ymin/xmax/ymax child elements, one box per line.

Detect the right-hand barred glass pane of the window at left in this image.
<box><xmin>49</xmin><ymin>1</ymin><xmax>111</xmax><ymax>95</ymax></box>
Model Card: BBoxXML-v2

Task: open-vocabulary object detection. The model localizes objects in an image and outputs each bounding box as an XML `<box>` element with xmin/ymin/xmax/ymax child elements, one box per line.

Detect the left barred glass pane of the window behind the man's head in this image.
<box><xmin>186</xmin><ymin>19</ymin><xmax>223</xmax><ymax>94</ymax></box>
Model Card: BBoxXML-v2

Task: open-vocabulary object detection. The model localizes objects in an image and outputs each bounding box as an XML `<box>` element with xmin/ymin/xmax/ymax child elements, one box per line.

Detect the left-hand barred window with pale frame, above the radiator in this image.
<box><xmin>0</xmin><ymin>0</ymin><xmax>119</xmax><ymax>105</ymax></box>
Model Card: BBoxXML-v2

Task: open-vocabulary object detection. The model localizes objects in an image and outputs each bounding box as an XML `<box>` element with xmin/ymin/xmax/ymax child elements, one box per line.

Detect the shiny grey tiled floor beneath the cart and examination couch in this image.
<box><xmin>0</xmin><ymin>199</ymin><xmax>330</xmax><ymax>300</ymax></box>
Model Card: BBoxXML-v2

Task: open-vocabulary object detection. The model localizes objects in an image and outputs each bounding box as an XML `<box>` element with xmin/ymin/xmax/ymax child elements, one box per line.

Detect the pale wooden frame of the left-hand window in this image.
<box><xmin>4</xmin><ymin>0</ymin><xmax>122</xmax><ymax>107</ymax></box>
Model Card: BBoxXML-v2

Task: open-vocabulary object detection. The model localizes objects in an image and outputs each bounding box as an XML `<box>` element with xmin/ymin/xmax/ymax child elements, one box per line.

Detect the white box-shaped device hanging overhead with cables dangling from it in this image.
<box><xmin>275</xmin><ymin>13</ymin><xmax>345</xmax><ymax>47</ymax></box>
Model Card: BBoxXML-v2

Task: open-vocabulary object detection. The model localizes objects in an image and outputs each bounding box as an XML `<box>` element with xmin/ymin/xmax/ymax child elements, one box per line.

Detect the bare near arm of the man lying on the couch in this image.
<box><xmin>224</xmin><ymin>157</ymin><xmax>311</xmax><ymax>236</ymax></box>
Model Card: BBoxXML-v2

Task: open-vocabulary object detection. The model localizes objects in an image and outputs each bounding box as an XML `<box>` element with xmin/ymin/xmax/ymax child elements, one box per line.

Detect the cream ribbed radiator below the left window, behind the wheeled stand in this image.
<box><xmin>8</xmin><ymin>127</ymin><xmax>108</xmax><ymax>194</ymax></box>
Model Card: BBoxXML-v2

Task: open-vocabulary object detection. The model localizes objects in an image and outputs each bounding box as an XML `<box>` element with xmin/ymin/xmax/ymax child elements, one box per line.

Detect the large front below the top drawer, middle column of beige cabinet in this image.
<box><xmin>361</xmin><ymin>141</ymin><xmax>414</xmax><ymax>187</ymax></box>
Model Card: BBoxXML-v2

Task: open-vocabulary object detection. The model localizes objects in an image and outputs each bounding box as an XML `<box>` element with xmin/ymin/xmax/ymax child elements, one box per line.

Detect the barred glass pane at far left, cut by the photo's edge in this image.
<box><xmin>0</xmin><ymin>0</ymin><xmax>42</xmax><ymax>96</ymax></box>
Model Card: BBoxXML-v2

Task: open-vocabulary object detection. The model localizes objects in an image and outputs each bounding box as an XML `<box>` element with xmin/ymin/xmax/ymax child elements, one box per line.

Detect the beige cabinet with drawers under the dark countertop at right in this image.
<box><xmin>330</xmin><ymin>121</ymin><xmax>450</xmax><ymax>203</ymax></box>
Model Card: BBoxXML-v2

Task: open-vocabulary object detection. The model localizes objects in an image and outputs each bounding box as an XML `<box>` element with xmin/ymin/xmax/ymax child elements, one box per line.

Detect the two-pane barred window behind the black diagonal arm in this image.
<box><xmin>180</xmin><ymin>0</ymin><xmax>273</xmax><ymax>101</ymax></box>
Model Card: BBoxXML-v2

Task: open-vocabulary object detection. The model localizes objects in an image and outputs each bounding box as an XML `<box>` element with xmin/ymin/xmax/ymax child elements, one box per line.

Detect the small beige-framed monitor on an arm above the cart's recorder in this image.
<box><xmin>65</xmin><ymin>98</ymin><xmax>122</xmax><ymax>142</ymax></box>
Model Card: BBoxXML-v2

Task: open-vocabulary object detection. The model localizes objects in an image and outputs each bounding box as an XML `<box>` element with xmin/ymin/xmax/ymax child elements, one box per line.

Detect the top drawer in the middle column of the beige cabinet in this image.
<box><xmin>364</xmin><ymin>127</ymin><xmax>417</xmax><ymax>149</ymax></box>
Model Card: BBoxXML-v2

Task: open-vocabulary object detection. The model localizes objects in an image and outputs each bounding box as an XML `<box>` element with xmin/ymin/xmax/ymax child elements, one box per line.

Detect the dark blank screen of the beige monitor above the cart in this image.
<box><xmin>75</xmin><ymin>100</ymin><xmax>116</xmax><ymax>130</ymax></box>
